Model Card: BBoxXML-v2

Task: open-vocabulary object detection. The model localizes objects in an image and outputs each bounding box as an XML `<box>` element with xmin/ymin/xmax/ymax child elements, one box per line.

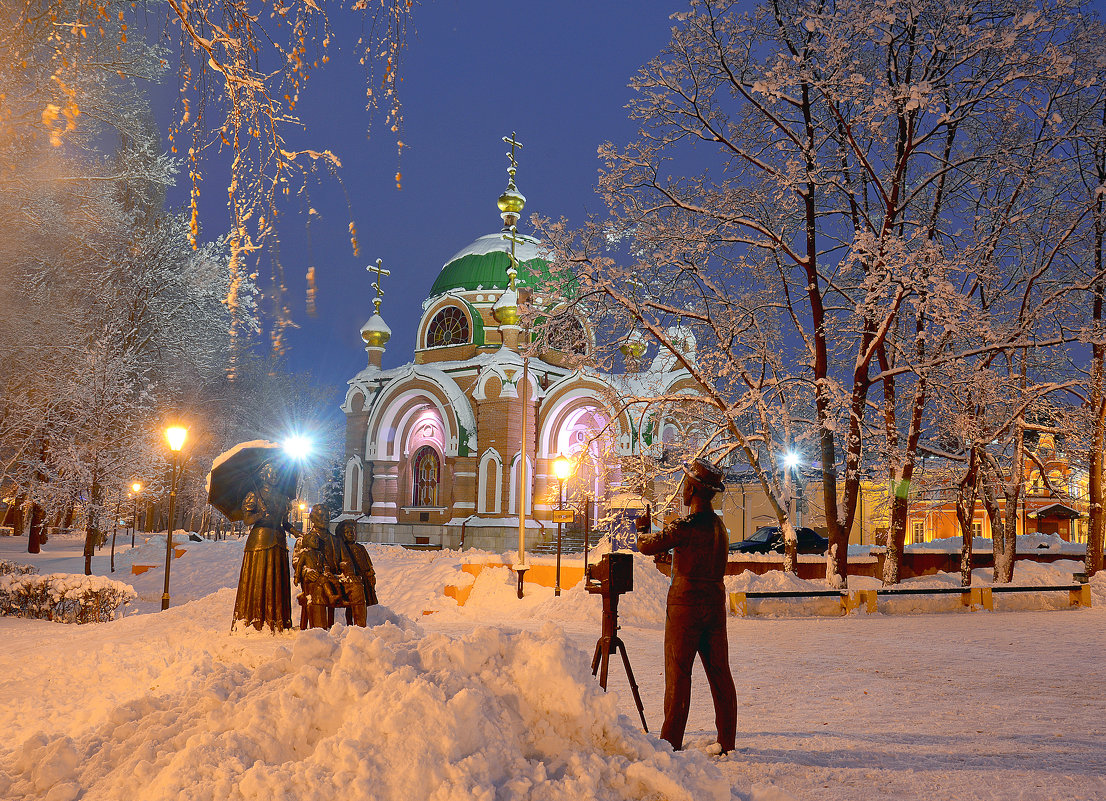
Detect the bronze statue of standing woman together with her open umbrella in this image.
<box><xmin>208</xmin><ymin>440</ymin><xmax>299</xmax><ymax>632</ymax></box>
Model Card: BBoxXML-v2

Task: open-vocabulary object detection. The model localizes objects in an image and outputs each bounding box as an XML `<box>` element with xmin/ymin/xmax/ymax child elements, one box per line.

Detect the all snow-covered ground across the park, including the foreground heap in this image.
<box><xmin>0</xmin><ymin>537</ymin><xmax>1106</xmax><ymax>801</ymax></box>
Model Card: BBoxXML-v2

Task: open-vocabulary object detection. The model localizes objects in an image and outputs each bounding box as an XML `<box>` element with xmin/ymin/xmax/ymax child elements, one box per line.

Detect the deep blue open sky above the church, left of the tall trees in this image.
<box><xmin>163</xmin><ymin>0</ymin><xmax>684</xmax><ymax>387</ymax></box>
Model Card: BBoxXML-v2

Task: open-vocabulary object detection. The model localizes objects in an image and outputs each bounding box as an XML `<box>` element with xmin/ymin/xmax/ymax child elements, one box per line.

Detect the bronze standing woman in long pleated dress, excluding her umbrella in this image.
<box><xmin>231</xmin><ymin>467</ymin><xmax>292</xmax><ymax>632</ymax></box>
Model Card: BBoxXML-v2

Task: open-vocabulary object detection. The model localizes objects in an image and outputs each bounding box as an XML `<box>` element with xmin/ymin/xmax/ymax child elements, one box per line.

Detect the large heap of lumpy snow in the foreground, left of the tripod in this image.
<box><xmin>0</xmin><ymin>593</ymin><xmax>731</xmax><ymax>801</ymax></box>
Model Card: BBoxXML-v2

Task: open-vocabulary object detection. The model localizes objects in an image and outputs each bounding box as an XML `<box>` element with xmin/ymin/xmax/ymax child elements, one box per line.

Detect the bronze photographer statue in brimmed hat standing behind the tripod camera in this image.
<box><xmin>635</xmin><ymin>459</ymin><xmax>738</xmax><ymax>753</ymax></box>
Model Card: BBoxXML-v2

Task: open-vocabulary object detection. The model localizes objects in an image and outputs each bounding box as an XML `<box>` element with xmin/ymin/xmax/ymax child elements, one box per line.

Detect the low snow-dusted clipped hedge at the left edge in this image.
<box><xmin>0</xmin><ymin>565</ymin><xmax>137</xmax><ymax>623</ymax></box>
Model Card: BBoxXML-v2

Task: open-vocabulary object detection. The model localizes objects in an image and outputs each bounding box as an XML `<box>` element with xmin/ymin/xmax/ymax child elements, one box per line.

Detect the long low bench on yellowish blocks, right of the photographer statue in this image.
<box><xmin>730</xmin><ymin>583</ymin><xmax>1091</xmax><ymax>617</ymax></box>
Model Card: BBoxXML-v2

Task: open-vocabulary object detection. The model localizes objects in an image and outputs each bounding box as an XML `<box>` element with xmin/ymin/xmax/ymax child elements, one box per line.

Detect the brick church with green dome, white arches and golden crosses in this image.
<box><xmin>338</xmin><ymin>137</ymin><xmax>695</xmax><ymax>551</ymax></box>
